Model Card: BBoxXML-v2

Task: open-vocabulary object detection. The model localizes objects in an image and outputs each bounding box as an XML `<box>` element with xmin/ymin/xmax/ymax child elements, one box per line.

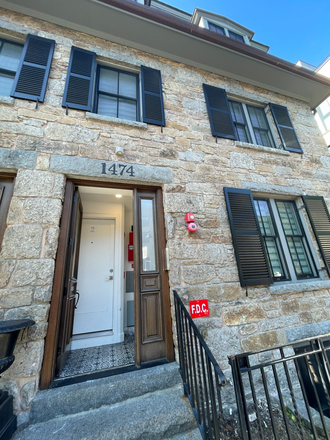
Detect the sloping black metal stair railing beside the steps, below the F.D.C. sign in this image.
<box><xmin>173</xmin><ymin>290</ymin><xmax>226</xmax><ymax>440</ymax></box>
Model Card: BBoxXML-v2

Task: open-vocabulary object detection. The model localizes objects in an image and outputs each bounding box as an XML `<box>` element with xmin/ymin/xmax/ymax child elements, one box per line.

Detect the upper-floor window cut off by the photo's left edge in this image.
<box><xmin>0</xmin><ymin>38</ymin><xmax>23</xmax><ymax>96</ymax></box>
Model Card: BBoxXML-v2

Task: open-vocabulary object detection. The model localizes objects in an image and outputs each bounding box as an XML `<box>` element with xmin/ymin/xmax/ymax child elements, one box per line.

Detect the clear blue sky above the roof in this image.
<box><xmin>169</xmin><ymin>0</ymin><xmax>330</xmax><ymax>66</ymax></box>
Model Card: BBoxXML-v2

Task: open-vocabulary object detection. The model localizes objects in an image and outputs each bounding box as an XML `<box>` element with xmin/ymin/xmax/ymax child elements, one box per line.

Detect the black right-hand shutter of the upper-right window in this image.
<box><xmin>269</xmin><ymin>103</ymin><xmax>303</xmax><ymax>153</ymax></box>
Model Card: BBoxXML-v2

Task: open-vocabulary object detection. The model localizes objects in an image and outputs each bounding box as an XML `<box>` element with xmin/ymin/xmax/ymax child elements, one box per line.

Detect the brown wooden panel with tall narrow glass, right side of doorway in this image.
<box><xmin>134</xmin><ymin>190</ymin><xmax>173</xmax><ymax>365</ymax></box>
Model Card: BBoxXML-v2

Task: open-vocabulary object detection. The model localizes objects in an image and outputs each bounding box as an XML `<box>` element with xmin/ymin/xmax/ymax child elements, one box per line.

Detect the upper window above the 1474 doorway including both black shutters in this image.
<box><xmin>62</xmin><ymin>46</ymin><xmax>165</xmax><ymax>127</ymax></box>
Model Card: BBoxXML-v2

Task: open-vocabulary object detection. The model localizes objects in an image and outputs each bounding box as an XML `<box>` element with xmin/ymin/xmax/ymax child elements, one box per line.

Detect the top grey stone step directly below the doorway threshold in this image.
<box><xmin>29</xmin><ymin>362</ymin><xmax>181</xmax><ymax>424</ymax></box>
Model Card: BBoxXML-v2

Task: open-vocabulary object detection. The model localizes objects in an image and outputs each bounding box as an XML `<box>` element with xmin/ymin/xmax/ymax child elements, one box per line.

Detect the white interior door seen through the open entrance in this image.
<box><xmin>73</xmin><ymin>219</ymin><xmax>115</xmax><ymax>336</ymax></box>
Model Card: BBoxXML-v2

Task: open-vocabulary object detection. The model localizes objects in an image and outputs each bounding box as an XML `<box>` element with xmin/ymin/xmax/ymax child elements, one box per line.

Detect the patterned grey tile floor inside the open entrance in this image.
<box><xmin>59</xmin><ymin>334</ymin><xmax>135</xmax><ymax>377</ymax></box>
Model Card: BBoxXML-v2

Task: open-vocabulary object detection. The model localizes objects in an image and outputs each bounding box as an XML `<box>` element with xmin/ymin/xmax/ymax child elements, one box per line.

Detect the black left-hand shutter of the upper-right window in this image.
<box><xmin>203</xmin><ymin>84</ymin><xmax>237</xmax><ymax>140</ymax></box>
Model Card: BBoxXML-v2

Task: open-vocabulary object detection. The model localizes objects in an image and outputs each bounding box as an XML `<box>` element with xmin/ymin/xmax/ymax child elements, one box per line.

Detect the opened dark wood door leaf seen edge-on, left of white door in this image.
<box><xmin>56</xmin><ymin>187</ymin><xmax>82</xmax><ymax>374</ymax></box>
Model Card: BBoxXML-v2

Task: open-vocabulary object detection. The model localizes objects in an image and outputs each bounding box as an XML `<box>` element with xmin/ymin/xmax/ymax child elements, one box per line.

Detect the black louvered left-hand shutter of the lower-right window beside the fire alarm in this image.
<box><xmin>224</xmin><ymin>188</ymin><xmax>273</xmax><ymax>287</ymax></box>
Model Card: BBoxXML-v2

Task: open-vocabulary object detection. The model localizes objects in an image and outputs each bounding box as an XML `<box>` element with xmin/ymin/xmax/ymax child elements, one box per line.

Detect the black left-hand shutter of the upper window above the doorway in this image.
<box><xmin>62</xmin><ymin>46</ymin><xmax>96</xmax><ymax>111</ymax></box>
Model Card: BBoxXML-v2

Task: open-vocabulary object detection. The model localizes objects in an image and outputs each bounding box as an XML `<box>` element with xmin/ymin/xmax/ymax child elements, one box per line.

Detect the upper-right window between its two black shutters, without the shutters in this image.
<box><xmin>229</xmin><ymin>101</ymin><xmax>275</xmax><ymax>148</ymax></box>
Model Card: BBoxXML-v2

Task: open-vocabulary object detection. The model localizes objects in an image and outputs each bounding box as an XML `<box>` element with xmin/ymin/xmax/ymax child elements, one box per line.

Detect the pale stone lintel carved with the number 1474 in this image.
<box><xmin>49</xmin><ymin>155</ymin><xmax>173</xmax><ymax>185</ymax></box>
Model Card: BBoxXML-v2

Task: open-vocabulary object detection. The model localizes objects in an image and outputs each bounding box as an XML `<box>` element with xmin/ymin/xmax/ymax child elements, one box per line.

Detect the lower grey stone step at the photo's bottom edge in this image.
<box><xmin>13</xmin><ymin>384</ymin><xmax>197</xmax><ymax>440</ymax></box>
